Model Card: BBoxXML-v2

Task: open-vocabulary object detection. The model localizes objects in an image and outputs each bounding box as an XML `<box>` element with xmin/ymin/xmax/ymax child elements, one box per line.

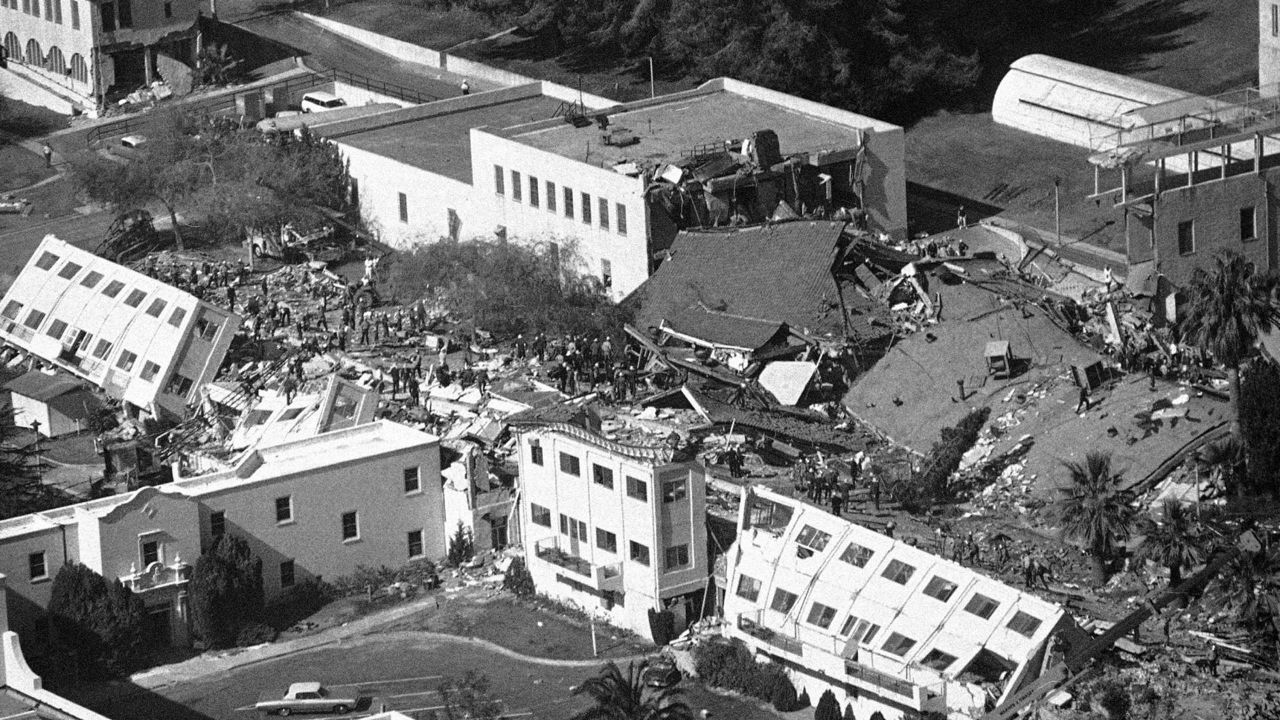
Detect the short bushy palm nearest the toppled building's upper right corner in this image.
<box><xmin>1053</xmin><ymin>452</ymin><xmax>1137</xmax><ymax>584</ymax></box>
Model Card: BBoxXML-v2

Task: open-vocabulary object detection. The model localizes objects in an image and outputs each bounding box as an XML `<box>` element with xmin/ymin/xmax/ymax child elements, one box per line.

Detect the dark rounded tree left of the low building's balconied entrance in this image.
<box><xmin>49</xmin><ymin>562</ymin><xmax>150</xmax><ymax>676</ymax></box>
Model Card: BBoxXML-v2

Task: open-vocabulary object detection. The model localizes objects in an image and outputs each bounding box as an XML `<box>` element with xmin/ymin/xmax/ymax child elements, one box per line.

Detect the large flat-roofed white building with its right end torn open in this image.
<box><xmin>324</xmin><ymin>78</ymin><xmax>906</xmax><ymax>297</ymax></box>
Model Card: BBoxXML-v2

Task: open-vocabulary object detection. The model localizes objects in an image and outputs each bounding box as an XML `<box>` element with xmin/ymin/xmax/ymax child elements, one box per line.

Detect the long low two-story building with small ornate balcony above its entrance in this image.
<box><xmin>0</xmin><ymin>420</ymin><xmax>448</xmax><ymax>651</ymax></box>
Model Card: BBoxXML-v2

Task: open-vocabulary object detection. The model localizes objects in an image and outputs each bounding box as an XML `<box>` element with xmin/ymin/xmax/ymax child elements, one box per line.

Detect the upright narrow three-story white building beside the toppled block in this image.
<box><xmin>520</xmin><ymin>423</ymin><xmax>708</xmax><ymax>638</ymax></box>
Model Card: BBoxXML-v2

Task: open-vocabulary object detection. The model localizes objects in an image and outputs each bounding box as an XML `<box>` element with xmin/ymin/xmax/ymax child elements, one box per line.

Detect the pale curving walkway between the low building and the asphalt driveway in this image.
<box><xmin>129</xmin><ymin>596</ymin><xmax>649</xmax><ymax>689</ymax></box>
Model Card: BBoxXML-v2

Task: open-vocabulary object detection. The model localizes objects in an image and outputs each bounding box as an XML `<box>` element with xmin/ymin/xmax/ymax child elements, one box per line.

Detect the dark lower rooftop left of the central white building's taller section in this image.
<box><xmin>334</xmin><ymin>95</ymin><xmax>563</xmax><ymax>184</ymax></box>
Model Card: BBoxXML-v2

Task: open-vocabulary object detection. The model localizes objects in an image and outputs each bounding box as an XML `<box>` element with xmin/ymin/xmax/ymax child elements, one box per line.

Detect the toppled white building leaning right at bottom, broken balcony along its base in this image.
<box><xmin>721</xmin><ymin>488</ymin><xmax>1075</xmax><ymax>720</ymax></box>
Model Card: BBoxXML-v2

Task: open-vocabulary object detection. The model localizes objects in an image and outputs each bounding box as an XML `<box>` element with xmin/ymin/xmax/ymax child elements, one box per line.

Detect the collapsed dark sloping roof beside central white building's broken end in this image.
<box><xmin>632</xmin><ymin>220</ymin><xmax>845</xmax><ymax>333</ymax></box>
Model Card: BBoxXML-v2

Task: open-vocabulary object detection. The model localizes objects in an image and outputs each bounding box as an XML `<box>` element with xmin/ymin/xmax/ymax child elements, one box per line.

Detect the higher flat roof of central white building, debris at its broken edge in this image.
<box><xmin>511</xmin><ymin>90</ymin><xmax>876</xmax><ymax>167</ymax></box>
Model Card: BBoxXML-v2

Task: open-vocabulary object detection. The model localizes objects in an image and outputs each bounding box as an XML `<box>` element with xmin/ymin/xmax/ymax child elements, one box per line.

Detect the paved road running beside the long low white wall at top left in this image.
<box><xmin>237</xmin><ymin>13</ymin><xmax>478</xmax><ymax>99</ymax></box>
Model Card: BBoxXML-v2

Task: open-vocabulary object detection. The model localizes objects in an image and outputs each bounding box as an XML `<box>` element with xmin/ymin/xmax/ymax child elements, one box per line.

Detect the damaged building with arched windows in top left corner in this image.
<box><xmin>0</xmin><ymin>0</ymin><xmax>202</xmax><ymax>114</ymax></box>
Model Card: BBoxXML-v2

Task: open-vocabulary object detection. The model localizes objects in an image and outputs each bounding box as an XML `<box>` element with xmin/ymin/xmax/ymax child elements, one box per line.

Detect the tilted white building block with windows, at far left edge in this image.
<box><xmin>0</xmin><ymin>234</ymin><xmax>241</xmax><ymax>418</ymax></box>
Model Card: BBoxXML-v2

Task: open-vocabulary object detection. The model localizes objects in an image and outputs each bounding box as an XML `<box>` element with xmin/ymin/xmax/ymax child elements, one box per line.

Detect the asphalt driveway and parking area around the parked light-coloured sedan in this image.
<box><xmin>91</xmin><ymin>634</ymin><xmax>776</xmax><ymax>720</ymax></box>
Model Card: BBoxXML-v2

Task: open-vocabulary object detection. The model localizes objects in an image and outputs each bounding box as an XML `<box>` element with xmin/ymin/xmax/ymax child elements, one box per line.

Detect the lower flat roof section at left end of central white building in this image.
<box><xmin>325</xmin><ymin>91</ymin><xmax>564</xmax><ymax>184</ymax></box>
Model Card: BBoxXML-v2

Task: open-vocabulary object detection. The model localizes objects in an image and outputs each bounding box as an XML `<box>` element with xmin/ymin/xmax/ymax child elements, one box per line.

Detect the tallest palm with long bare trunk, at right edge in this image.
<box><xmin>1180</xmin><ymin>252</ymin><xmax>1276</xmax><ymax>437</ymax></box>
